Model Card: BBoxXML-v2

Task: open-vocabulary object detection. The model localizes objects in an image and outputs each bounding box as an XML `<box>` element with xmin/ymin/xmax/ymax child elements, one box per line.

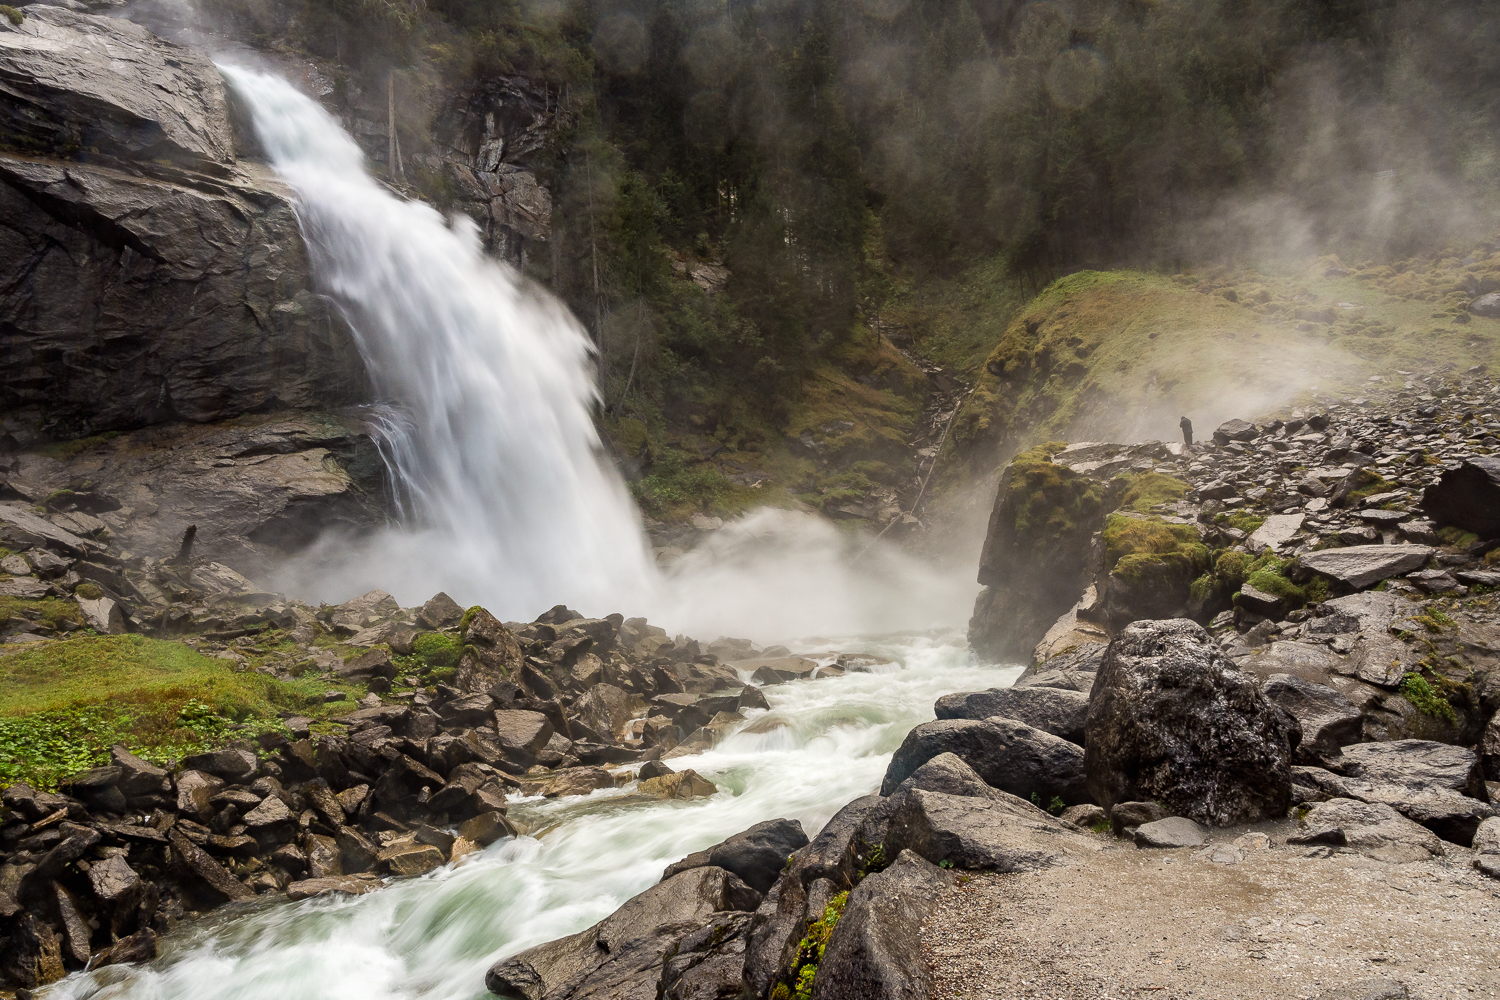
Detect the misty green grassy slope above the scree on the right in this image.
<box><xmin>944</xmin><ymin>245</ymin><xmax>1500</xmax><ymax>484</ymax></box>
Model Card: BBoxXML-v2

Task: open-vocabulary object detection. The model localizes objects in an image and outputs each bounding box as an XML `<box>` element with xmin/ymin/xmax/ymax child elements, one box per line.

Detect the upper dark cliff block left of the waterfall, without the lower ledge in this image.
<box><xmin>0</xmin><ymin>6</ymin><xmax>365</xmax><ymax>438</ymax></box>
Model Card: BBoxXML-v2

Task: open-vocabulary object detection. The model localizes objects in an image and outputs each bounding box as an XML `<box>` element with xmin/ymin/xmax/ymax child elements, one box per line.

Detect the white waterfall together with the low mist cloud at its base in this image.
<box><xmin>224</xmin><ymin>67</ymin><xmax>978</xmax><ymax>642</ymax></box>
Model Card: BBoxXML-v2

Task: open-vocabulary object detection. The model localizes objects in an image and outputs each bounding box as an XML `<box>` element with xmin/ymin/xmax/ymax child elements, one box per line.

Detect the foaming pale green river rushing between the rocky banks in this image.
<box><xmin>55</xmin><ymin>634</ymin><xmax>1020</xmax><ymax>1000</ymax></box>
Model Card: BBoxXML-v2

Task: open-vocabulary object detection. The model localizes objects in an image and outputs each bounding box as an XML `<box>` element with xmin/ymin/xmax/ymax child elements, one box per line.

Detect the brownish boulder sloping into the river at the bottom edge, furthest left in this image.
<box><xmin>485</xmin><ymin>868</ymin><xmax>761</xmax><ymax>1000</ymax></box>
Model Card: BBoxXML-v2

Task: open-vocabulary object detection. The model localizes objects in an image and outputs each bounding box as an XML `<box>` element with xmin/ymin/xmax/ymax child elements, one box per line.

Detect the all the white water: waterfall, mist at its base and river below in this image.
<box><xmin>48</xmin><ymin>62</ymin><xmax>1019</xmax><ymax>1000</ymax></box>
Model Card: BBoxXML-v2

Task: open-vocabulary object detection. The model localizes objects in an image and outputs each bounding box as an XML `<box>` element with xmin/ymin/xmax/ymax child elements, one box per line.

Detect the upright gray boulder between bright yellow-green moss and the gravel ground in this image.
<box><xmin>813</xmin><ymin>852</ymin><xmax>953</xmax><ymax>1000</ymax></box>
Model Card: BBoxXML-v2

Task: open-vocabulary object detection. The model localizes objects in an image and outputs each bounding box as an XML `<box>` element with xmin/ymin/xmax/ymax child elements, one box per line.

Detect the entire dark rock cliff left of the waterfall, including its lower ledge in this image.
<box><xmin>0</xmin><ymin>4</ymin><xmax>384</xmax><ymax>574</ymax></box>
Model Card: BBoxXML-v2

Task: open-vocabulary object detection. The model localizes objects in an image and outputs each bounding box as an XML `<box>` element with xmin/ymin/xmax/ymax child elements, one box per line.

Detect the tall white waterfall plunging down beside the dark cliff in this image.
<box><xmin>222</xmin><ymin>66</ymin><xmax>656</xmax><ymax>619</ymax></box>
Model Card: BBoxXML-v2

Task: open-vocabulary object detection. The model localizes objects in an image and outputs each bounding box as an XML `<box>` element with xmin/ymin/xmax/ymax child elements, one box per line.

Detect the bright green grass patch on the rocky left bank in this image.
<box><xmin>0</xmin><ymin>636</ymin><xmax>363</xmax><ymax>787</ymax></box>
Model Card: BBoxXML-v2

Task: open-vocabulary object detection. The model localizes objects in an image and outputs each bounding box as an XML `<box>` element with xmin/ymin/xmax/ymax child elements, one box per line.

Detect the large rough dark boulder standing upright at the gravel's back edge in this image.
<box><xmin>1086</xmin><ymin>619</ymin><xmax>1296</xmax><ymax>826</ymax></box>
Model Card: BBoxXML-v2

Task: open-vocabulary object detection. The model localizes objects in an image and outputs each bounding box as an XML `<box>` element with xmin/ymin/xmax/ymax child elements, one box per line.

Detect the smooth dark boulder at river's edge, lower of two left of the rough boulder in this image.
<box><xmin>881</xmin><ymin>718</ymin><xmax>1091</xmax><ymax>805</ymax></box>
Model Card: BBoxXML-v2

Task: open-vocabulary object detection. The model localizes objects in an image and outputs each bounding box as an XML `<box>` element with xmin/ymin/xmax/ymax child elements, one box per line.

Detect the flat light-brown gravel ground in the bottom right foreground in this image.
<box><xmin>924</xmin><ymin>826</ymin><xmax>1500</xmax><ymax>1000</ymax></box>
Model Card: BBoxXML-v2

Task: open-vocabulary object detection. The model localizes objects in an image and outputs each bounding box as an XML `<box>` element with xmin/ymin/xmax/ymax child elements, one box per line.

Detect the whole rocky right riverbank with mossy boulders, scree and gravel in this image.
<box><xmin>486</xmin><ymin>373</ymin><xmax>1500</xmax><ymax>1000</ymax></box>
